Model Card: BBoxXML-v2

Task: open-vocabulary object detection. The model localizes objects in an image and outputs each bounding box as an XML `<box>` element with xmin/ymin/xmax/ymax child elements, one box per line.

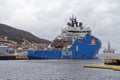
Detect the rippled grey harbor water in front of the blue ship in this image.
<box><xmin>0</xmin><ymin>54</ymin><xmax>120</xmax><ymax>80</ymax></box>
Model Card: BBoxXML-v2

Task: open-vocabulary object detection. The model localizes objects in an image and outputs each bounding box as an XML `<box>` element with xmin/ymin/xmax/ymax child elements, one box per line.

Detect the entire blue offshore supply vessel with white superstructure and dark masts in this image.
<box><xmin>27</xmin><ymin>16</ymin><xmax>101</xmax><ymax>59</ymax></box>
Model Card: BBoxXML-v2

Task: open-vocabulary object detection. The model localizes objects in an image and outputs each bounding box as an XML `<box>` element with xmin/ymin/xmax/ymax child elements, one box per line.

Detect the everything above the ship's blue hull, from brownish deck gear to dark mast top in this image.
<box><xmin>51</xmin><ymin>16</ymin><xmax>91</xmax><ymax>48</ymax></box>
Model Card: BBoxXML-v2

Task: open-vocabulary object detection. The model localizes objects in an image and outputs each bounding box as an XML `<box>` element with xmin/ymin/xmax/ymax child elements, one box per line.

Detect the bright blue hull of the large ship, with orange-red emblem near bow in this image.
<box><xmin>27</xmin><ymin>35</ymin><xmax>101</xmax><ymax>59</ymax></box>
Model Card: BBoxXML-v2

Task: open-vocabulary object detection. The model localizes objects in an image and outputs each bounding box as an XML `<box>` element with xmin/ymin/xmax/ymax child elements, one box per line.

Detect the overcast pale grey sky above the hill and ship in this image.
<box><xmin>0</xmin><ymin>0</ymin><xmax>120</xmax><ymax>52</ymax></box>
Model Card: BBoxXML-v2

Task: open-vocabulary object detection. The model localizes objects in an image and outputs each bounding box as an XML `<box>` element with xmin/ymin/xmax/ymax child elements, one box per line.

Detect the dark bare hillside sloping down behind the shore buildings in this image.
<box><xmin>0</xmin><ymin>24</ymin><xmax>50</xmax><ymax>44</ymax></box>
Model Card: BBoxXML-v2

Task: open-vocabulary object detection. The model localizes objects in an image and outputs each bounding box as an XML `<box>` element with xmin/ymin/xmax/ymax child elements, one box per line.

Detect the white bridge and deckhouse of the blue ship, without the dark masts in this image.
<box><xmin>57</xmin><ymin>22</ymin><xmax>91</xmax><ymax>42</ymax></box>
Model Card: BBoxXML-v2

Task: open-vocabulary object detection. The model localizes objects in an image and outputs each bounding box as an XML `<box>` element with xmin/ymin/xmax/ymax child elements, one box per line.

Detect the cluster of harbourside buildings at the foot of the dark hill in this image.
<box><xmin>0</xmin><ymin>36</ymin><xmax>47</xmax><ymax>53</ymax></box>
